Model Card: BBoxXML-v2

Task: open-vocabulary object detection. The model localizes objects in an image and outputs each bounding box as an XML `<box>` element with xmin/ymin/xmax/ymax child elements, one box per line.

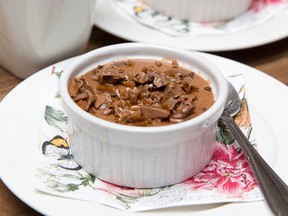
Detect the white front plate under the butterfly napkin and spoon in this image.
<box><xmin>0</xmin><ymin>53</ymin><xmax>288</xmax><ymax>216</ymax></box>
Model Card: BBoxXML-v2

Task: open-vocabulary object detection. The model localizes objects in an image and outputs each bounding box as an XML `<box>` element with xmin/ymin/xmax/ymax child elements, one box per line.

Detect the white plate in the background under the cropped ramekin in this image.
<box><xmin>94</xmin><ymin>0</ymin><xmax>288</xmax><ymax>51</ymax></box>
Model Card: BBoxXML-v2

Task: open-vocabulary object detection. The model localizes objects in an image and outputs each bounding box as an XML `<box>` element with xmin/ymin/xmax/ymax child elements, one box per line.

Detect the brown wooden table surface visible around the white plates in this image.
<box><xmin>0</xmin><ymin>27</ymin><xmax>288</xmax><ymax>216</ymax></box>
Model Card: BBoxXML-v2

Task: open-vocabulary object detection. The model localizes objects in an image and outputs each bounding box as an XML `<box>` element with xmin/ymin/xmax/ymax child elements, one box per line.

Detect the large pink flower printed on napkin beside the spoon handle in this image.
<box><xmin>185</xmin><ymin>142</ymin><xmax>257</xmax><ymax>196</ymax></box>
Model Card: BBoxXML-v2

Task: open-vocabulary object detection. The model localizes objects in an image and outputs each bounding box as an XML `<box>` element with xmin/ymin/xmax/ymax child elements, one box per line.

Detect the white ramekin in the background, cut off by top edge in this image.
<box><xmin>144</xmin><ymin>0</ymin><xmax>252</xmax><ymax>22</ymax></box>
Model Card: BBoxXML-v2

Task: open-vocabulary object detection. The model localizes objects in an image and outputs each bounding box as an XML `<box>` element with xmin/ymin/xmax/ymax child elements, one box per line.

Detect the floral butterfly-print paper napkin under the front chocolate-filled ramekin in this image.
<box><xmin>35</xmin><ymin>67</ymin><xmax>262</xmax><ymax>211</ymax></box>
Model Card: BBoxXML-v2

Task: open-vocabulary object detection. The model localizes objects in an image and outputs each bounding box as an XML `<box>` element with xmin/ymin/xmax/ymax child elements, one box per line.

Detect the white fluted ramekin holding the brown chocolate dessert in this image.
<box><xmin>60</xmin><ymin>43</ymin><xmax>227</xmax><ymax>188</ymax></box>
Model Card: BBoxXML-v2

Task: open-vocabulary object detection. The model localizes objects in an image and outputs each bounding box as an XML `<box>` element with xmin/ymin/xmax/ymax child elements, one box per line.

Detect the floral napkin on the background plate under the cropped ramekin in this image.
<box><xmin>110</xmin><ymin>0</ymin><xmax>288</xmax><ymax>36</ymax></box>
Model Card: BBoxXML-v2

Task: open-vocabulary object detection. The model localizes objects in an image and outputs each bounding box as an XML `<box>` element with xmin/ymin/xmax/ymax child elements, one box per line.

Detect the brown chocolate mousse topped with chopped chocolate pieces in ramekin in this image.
<box><xmin>69</xmin><ymin>59</ymin><xmax>214</xmax><ymax>126</ymax></box>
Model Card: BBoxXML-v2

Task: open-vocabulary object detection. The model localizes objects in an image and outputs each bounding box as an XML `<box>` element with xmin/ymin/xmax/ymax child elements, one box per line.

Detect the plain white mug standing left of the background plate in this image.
<box><xmin>0</xmin><ymin>0</ymin><xmax>95</xmax><ymax>79</ymax></box>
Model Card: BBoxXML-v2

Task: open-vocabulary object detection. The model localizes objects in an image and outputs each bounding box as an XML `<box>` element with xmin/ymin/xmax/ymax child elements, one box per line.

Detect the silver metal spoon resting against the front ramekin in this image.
<box><xmin>220</xmin><ymin>84</ymin><xmax>288</xmax><ymax>216</ymax></box>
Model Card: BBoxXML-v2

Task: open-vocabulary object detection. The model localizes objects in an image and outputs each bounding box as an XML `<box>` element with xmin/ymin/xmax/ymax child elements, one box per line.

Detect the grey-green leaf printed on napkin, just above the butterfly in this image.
<box><xmin>45</xmin><ymin>106</ymin><xmax>67</xmax><ymax>132</ymax></box>
